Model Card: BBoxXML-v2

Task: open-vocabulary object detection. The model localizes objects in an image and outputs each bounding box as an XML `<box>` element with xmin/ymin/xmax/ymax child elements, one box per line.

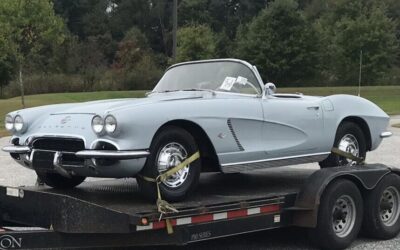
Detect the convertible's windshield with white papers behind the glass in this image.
<box><xmin>153</xmin><ymin>61</ymin><xmax>261</xmax><ymax>94</ymax></box>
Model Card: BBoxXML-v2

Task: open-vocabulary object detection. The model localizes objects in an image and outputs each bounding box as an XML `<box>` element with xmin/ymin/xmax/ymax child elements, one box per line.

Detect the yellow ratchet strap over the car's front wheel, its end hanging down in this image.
<box><xmin>140</xmin><ymin>151</ymin><xmax>200</xmax><ymax>234</ymax></box>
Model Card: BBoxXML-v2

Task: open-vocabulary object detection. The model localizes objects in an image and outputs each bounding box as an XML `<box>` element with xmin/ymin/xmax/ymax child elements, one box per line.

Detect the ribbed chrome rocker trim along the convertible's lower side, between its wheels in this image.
<box><xmin>221</xmin><ymin>152</ymin><xmax>330</xmax><ymax>173</ymax></box>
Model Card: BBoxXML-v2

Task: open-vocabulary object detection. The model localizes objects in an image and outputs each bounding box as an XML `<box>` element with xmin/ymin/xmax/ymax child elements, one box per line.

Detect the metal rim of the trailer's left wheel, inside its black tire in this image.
<box><xmin>332</xmin><ymin>195</ymin><xmax>356</xmax><ymax>238</ymax></box>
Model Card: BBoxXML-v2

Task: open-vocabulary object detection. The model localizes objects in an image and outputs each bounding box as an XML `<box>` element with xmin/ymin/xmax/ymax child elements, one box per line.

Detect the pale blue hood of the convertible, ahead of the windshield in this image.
<box><xmin>53</xmin><ymin>92</ymin><xmax>205</xmax><ymax>114</ymax></box>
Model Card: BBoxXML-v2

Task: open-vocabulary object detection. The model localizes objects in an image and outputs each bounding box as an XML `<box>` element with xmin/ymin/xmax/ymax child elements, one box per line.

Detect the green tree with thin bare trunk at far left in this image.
<box><xmin>0</xmin><ymin>0</ymin><xmax>64</xmax><ymax>107</ymax></box>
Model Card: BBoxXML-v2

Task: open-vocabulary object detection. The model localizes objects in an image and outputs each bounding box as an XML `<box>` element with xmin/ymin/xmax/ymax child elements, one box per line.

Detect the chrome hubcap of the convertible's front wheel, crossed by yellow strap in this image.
<box><xmin>157</xmin><ymin>142</ymin><xmax>190</xmax><ymax>188</ymax></box>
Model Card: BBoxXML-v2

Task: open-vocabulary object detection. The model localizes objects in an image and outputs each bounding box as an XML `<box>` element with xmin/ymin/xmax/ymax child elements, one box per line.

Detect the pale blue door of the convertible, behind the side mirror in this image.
<box><xmin>262</xmin><ymin>95</ymin><xmax>323</xmax><ymax>159</ymax></box>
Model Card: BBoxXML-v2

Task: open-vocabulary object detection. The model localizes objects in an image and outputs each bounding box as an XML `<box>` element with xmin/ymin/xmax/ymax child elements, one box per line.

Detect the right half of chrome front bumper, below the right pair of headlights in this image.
<box><xmin>75</xmin><ymin>150</ymin><xmax>150</xmax><ymax>160</ymax></box>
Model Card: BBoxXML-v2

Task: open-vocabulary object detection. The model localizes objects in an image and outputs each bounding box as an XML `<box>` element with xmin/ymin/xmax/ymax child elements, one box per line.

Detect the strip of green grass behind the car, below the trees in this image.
<box><xmin>0</xmin><ymin>86</ymin><xmax>400</xmax><ymax>137</ymax></box>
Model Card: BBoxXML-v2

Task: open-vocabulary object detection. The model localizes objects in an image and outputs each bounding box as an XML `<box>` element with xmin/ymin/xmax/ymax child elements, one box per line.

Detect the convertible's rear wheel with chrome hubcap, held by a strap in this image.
<box><xmin>319</xmin><ymin>121</ymin><xmax>367</xmax><ymax>168</ymax></box>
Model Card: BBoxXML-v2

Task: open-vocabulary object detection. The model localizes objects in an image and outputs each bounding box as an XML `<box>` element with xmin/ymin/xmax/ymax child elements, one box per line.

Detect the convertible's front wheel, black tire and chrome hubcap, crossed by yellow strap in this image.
<box><xmin>137</xmin><ymin>126</ymin><xmax>201</xmax><ymax>201</ymax></box>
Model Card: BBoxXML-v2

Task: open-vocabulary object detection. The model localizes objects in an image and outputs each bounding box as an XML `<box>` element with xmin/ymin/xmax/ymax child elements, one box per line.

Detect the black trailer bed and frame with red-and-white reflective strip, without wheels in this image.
<box><xmin>0</xmin><ymin>164</ymin><xmax>393</xmax><ymax>249</ymax></box>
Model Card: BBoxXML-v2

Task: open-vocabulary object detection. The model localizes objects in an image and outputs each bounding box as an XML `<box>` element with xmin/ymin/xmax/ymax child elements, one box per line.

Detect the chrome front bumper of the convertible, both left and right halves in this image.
<box><xmin>2</xmin><ymin>145</ymin><xmax>150</xmax><ymax>160</ymax></box>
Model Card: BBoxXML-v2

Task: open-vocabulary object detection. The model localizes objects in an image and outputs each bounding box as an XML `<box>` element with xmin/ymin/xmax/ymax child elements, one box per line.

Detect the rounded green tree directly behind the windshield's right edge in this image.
<box><xmin>234</xmin><ymin>0</ymin><xmax>318</xmax><ymax>85</ymax></box>
